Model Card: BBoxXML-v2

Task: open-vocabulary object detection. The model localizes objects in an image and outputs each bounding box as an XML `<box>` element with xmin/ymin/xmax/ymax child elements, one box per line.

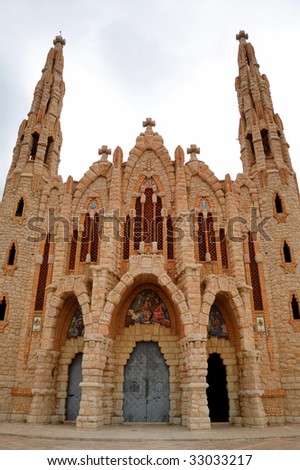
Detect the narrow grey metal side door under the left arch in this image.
<box><xmin>66</xmin><ymin>353</ymin><xmax>82</xmax><ymax>421</ymax></box>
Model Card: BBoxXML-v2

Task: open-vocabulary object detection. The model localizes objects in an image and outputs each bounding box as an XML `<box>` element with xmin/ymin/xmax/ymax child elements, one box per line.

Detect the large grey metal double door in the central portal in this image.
<box><xmin>124</xmin><ymin>342</ymin><xmax>170</xmax><ymax>423</ymax></box>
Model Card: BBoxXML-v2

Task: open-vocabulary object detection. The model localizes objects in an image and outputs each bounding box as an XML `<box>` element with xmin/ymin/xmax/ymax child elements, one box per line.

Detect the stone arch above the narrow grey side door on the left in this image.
<box><xmin>41</xmin><ymin>276</ymin><xmax>91</xmax><ymax>350</ymax></box>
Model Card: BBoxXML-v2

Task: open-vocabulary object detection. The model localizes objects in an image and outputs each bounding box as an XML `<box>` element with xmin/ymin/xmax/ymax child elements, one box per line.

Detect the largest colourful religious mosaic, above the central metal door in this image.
<box><xmin>125</xmin><ymin>289</ymin><xmax>171</xmax><ymax>326</ymax></box>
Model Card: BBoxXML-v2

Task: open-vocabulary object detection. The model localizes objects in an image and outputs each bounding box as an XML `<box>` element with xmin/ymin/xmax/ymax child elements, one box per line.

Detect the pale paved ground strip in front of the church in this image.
<box><xmin>0</xmin><ymin>423</ymin><xmax>300</xmax><ymax>450</ymax></box>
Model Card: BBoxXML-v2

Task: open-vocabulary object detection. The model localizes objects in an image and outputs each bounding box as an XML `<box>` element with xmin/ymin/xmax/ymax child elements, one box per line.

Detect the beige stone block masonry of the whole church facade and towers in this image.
<box><xmin>0</xmin><ymin>40</ymin><xmax>300</xmax><ymax>430</ymax></box>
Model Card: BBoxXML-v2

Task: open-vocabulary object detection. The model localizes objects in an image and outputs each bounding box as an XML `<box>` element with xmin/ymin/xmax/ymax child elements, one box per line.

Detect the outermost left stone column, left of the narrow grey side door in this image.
<box><xmin>27</xmin><ymin>349</ymin><xmax>59</xmax><ymax>424</ymax></box>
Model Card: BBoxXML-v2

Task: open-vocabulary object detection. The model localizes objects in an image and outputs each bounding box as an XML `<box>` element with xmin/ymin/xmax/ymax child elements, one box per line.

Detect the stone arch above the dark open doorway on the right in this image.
<box><xmin>200</xmin><ymin>275</ymin><xmax>254</xmax><ymax>351</ymax></box>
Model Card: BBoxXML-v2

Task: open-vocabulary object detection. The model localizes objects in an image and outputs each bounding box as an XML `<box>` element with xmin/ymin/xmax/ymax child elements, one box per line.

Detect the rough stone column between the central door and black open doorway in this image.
<box><xmin>182</xmin><ymin>334</ymin><xmax>210</xmax><ymax>431</ymax></box>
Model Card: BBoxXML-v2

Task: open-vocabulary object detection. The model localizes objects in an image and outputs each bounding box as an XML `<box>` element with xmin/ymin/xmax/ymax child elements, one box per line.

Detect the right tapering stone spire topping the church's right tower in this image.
<box><xmin>235</xmin><ymin>31</ymin><xmax>291</xmax><ymax>178</ymax></box>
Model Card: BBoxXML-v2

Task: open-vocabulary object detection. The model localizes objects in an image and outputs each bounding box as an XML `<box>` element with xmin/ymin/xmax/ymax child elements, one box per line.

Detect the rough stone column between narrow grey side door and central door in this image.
<box><xmin>76</xmin><ymin>334</ymin><xmax>109</xmax><ymax>430</ymax></box>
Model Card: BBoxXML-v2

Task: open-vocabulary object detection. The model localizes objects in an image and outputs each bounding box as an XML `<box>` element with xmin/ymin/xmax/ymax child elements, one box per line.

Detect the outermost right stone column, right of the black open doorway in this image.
<box><xmin>237</xmin><ymin>350</ymin><xmax>267</xmax><ymax>427</ymax></box>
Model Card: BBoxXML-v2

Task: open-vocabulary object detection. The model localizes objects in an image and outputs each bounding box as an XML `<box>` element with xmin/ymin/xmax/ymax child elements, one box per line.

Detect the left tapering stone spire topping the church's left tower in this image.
<box><xmin>10</xmin><ymin>35</ymin><xmax>65</xmax><ymax>186</ymax></box>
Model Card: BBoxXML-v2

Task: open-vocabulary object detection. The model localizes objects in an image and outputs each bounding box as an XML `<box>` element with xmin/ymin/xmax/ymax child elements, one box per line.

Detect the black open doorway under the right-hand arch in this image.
<box><xmin>206</xmin><ymin>353</ymin><xmax>229</xmax><ymax>423</ymax></box>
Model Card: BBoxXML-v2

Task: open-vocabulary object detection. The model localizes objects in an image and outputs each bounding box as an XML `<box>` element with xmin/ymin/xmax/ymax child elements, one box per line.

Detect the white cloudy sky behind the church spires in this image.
<box><xmin>0</xmin><ymin>0</ymin><xmax>300</xmax><ymax>195</ymax></box>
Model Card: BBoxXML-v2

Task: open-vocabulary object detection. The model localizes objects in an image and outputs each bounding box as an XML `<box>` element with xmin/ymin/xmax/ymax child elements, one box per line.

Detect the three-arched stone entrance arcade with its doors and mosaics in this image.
<box><xmin>27</xmin><ymin>255</ymin><xmax>265</xmax><ymax>429</ymax></box>
